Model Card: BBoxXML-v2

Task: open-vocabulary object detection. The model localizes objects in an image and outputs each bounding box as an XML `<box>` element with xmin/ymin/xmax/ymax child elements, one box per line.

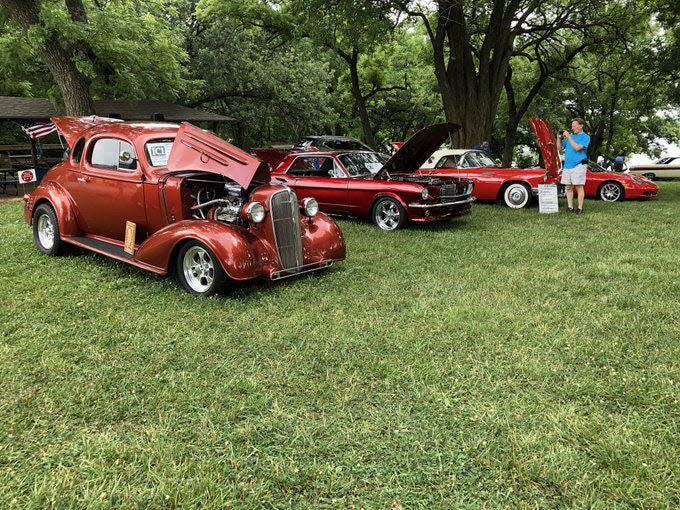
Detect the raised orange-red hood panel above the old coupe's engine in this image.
<box><xmin>167</xmin><ymin>122</ymin><xmax>270</xmax><ymax>189</ymax></box>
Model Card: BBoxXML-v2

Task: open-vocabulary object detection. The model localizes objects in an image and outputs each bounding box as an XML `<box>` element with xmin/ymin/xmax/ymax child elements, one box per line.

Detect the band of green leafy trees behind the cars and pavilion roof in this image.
<box><xmin>0</xmin><ymin>0</ymin><xmax>680</xmax><ymax>159</ymax></box>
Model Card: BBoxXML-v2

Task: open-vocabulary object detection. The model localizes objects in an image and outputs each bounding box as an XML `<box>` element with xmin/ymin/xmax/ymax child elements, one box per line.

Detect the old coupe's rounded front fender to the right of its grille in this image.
<box><xmin>300</xmin><ymin>212</ymin><xmax>346</xmax><ymax>264</ymax></box>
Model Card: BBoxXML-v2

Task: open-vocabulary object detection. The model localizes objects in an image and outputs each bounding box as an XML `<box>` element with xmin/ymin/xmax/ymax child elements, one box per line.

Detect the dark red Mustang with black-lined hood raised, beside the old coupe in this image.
<box><xmin>254</xmin><ymin>124</ymin><xmax>474</xmax><ymax>230</ymax></box>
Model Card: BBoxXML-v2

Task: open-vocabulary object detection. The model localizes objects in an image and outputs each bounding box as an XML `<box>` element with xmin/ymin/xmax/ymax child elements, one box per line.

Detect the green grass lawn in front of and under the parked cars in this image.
<box><xmin>0</xmin><ymin>183</ymin><xmax>680</xmax><ymax>509</ymax></box>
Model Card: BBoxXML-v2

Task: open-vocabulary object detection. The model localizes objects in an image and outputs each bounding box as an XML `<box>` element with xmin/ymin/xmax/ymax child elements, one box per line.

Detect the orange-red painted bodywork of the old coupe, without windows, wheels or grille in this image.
<box><xmin>24</xmin><ymin>117</ymin><xmax>345</xmax><ymax>280</ymax></box>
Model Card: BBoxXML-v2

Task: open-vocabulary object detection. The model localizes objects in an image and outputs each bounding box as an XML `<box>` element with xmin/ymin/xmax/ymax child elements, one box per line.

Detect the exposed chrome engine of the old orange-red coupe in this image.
<box><xmin>184</xmin><ymin>178</ymin><xmax>247</xmax><ymax>225</ymax></box>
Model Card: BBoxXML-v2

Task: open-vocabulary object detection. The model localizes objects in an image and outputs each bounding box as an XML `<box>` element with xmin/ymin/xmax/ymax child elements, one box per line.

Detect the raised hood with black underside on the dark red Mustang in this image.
<box><xmin>375</xmin><ymin>122</ymin><xmax>460</xmax><ymax>179</ymax></box>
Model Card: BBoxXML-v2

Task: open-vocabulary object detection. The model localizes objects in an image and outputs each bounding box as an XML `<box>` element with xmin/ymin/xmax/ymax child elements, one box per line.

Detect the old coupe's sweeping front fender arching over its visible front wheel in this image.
<box><xmin>135</xmin><ymin>220</ymin><xmax>271</xmax><ymax>280</ymax></box>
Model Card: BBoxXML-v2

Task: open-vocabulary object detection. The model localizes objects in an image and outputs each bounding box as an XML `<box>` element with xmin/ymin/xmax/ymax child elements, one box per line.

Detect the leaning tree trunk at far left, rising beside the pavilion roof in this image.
<box><xmin>0</xmin><ymin>0</ymin><xmax>94</xmax><ymax>115</ymax></box>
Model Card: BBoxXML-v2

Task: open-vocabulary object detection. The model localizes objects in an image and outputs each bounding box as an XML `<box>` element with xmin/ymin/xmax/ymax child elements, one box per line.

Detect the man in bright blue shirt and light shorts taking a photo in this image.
<box><xmin>557</xmin><ymin>118</ymin><xmax>590</xmax><ymax>214</ymax></box>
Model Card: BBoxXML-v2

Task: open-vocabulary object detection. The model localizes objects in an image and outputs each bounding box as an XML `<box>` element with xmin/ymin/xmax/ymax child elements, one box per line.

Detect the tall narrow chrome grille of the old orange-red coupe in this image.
<box><xmin>269</xmin><ymin>188</ymin><xmax>302</xmax><ymax>269</ymax></box>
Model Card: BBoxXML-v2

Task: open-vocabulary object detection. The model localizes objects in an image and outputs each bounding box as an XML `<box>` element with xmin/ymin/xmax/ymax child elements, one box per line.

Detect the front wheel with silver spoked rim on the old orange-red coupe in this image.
<box><xmin>177</xmin><ymin>241</ymin><xmax>227</xmax><ymax>297</ymax></box>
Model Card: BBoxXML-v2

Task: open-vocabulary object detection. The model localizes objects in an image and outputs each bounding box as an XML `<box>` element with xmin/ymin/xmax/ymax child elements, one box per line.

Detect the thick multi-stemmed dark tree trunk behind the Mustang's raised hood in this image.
<box><xmin>394</xmin><ymin>0</ymin><xmax>620</xmax><ymax>147</ymax></box>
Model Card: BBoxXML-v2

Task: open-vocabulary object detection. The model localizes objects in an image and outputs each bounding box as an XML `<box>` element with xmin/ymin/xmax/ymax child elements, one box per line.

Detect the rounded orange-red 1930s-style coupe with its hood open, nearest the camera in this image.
<box><xmin>24</xmin><ymin>117</ymin><xmax>345</xmax><ymax>296</ymax></box>
